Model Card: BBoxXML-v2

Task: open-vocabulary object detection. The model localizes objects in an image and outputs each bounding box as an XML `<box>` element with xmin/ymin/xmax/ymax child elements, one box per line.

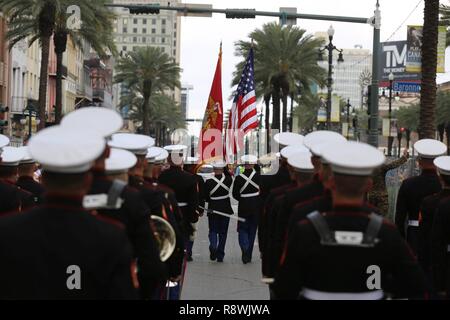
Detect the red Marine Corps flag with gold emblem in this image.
<box><xmin>198</xmin><ymin>43</ymin><xmax>223</xmax><ymax>161</ymax></box>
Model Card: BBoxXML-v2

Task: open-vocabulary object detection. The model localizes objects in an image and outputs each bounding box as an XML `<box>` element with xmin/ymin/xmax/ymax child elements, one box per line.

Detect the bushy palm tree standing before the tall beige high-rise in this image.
<box><xmin>114</xmin><ymin>47</ymin><xmax>181</xmax><ymax>135</ymax></box>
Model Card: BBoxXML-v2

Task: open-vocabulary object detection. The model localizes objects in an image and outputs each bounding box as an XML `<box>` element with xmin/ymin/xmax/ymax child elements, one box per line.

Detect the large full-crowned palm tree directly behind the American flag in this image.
<box><xmin>233</xmin><ymin>22</ymin><xmax>325</xmax><ymax>131</ymax></box>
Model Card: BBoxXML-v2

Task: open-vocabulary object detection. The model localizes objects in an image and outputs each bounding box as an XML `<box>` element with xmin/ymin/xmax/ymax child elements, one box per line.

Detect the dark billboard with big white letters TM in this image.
<box><xmin>379</xmin><ymin>41</ymin><xmax>421</xmax><ymax>81</ymax></box>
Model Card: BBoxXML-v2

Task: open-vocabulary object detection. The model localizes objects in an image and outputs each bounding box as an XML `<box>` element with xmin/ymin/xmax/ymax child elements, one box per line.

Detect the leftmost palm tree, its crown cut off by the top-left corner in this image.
<box><xmin>0</xmin><ymin>0</ymin><xmax>57</xmax><ymax>129</ymax></box>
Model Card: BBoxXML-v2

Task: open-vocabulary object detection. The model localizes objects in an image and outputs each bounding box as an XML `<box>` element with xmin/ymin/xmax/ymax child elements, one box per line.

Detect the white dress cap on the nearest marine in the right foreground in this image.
<box><xmin>322</xmin><ymin>141</ymin><xmax>385</xmax><ymax>176</ymax></box>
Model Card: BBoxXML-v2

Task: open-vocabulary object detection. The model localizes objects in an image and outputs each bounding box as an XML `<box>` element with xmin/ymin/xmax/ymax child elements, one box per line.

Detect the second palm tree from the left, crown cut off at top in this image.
<box><xmin>53</xmin><ymin>0</ymin><xmax>116</xmax><ymax>123</ymax></box>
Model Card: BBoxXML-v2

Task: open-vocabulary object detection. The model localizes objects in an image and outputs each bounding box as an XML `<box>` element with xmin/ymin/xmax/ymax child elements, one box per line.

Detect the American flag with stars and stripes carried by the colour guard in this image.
<box><xmin>225</xmin><ymin>48</ymin><xmax>258</xmax><ymax>157</ymax></box>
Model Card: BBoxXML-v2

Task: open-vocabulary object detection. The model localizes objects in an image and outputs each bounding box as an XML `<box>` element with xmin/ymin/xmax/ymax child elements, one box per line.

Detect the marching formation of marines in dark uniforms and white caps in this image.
<box><xmin>0</xmin><ymin>107</ymin><xmax>450</xmax><ymax>300</ymax></box>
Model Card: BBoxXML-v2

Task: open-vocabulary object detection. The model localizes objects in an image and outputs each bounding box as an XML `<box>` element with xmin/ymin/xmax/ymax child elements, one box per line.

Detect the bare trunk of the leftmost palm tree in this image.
<box><xmin>38</xmin><ymin>1</ymin><xmax>56</xmax><ymax>130</ymax></box>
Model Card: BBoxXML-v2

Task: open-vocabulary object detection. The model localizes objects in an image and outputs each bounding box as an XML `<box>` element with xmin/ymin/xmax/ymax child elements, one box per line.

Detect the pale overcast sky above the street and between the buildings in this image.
<box><xmin>181</xmin><ymin>0</ymin><xmax>450</xmax><ymax>135</ymax></box>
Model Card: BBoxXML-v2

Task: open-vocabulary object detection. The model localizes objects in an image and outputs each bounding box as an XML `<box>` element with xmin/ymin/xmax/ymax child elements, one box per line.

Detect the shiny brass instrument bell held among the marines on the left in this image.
<box><xmin>150</xmin><ymin>215</ymin><xmax>176</xmax><ymax>262</ymax></box>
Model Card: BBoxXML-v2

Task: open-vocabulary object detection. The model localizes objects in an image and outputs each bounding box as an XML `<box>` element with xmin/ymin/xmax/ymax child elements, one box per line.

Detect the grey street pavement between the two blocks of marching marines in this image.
<box><xmin>181</xmin><ymin>206</ymin><xmax>269</xmax><ymax>300</ymax></box>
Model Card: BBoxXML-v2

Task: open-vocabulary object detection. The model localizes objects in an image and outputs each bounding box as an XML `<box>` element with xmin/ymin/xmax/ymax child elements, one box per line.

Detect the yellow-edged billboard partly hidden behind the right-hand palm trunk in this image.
<box><xmin>406</xmin><ymin>26</ymin><xmax>447</xmax><ymax>73</ymax></box>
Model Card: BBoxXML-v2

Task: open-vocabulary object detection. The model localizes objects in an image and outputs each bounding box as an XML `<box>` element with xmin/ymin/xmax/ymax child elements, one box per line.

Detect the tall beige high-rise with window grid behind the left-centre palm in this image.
<box><xmin>113</xmin><ymin>0</ymin><xmax>181</xmax><ymax>106</ymax></box>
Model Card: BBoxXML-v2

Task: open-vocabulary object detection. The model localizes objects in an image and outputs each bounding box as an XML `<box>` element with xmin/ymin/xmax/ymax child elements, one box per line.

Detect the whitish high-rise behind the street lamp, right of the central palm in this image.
<box><xmin>315</xmin><ymin>32</ymin><xmax>372</xmax><ymax>108</ymax></box>
